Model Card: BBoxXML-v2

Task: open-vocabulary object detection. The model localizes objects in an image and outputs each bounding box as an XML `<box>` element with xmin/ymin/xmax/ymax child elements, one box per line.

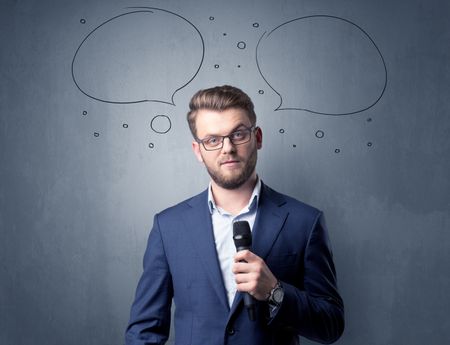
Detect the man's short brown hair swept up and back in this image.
<box><xmin>187</xmin><ymin>85</ymin><xmax>256</xmax><ymax>137</ymax></box>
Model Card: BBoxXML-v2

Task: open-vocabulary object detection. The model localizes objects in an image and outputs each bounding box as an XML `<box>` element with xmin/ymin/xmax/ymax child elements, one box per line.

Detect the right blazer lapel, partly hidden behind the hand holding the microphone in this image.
<box><xmin>230</xmin><ymin>184</ymin><xmax>288</xmax><ymax>317</ymax></box>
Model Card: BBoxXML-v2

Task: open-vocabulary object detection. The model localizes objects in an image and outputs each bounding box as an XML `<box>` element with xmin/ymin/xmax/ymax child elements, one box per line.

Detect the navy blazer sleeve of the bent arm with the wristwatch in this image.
<box><xmin>269</xmin><ymin>213</ymin><xmax>344</xmax><ymax>344</ymax></box>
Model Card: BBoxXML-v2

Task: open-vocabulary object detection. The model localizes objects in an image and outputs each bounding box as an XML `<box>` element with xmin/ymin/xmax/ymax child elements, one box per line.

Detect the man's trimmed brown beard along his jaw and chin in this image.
<box><xmin>205</xmin><ymin>149</ymin><xmax>258</xmax><ymax>190</ymax></box>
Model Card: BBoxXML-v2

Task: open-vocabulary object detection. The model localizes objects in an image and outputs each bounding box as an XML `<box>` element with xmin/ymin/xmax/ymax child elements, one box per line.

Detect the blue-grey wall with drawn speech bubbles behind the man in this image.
<box><xmin>0</xmin><ymin>0</ymin><xmax>450</xmax><ymax>345</ymax></box>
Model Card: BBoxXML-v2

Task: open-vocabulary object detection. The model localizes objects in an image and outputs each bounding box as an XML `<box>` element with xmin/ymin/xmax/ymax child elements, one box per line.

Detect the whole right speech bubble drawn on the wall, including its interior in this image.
<box><xmin>256</xmin><ymin>15</ymin><xmax>387</xmax><ymax>115</ymax></box>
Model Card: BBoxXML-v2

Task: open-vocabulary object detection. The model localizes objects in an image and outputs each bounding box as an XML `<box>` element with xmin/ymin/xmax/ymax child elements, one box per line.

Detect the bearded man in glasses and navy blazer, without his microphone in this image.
<box><xmin>126</xmin><ymin>86</ymin><xmax>344</xmax><ymax>345</ymax></box>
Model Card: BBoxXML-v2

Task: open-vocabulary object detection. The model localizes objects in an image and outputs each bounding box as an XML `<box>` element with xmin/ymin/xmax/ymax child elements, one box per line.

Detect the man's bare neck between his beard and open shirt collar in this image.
<box><xmin>211</xmin><ymin>173</ymin><xmax>258</xmax><ymax>215</ymax></box>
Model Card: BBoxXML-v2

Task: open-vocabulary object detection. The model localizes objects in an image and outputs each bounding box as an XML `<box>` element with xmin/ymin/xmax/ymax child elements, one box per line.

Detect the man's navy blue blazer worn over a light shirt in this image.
<box><xmin>126</xmin><ymin>184</ymin><xmax>344</xmax><ymax>345</ymax></box>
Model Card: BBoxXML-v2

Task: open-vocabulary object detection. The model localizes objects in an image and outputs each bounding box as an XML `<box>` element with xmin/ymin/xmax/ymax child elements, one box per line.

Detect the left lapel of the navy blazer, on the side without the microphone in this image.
<box><xmin>183</xmin><ymin>191</ymin><xmax>229</xmax><ymax>310</ymax></box>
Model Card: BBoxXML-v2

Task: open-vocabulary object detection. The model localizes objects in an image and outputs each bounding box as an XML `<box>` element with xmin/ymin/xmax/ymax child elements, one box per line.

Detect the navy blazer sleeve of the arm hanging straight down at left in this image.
<box><xmin>125</xmin><ymin>215</ymin><xmax>173</xmax><ymax>345</ymax></box>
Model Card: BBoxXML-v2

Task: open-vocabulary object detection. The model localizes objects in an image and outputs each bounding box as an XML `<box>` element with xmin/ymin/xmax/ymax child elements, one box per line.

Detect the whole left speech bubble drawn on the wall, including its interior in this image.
<box><xmin>72</xmin><ymin>7</ymin><xmax>205</xmax><ymax>105</ymax></box>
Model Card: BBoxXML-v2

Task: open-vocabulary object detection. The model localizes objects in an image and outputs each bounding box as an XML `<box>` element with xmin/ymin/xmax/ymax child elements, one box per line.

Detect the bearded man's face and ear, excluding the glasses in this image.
<box><xmin>192</xmin><ymin>108</ymin><xmax>262</xmax><ymax>189</ymax></box>
